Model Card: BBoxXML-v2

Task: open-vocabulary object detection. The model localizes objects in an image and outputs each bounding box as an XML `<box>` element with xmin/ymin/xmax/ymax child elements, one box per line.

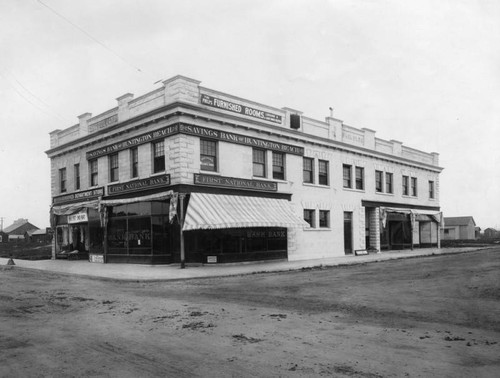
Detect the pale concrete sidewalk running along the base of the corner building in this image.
<box><xmin>0</xmin><ymin>247</ymin><xmax>487</xmax><ymax>281</ymax></box>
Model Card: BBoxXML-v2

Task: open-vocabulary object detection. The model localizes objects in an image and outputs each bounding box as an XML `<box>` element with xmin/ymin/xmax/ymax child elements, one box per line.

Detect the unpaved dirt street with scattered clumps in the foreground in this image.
<box><xmin>0</xmin><ymin>249</ymin><xmax>500</xmax><ymax>377</ymax></box>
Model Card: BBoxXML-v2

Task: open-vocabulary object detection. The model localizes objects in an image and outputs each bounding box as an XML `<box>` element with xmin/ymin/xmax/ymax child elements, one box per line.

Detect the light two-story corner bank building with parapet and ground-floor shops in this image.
<box><xmin>47</xmin><ymin>76</ymin><xmax>442</xmax><ymax>263</ymax></box>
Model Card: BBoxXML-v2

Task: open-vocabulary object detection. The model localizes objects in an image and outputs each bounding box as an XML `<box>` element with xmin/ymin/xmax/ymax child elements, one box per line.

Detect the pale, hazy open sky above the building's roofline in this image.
<box><xmin>0</xmin><ymin>0</ymin><xmax>500</xmax><ymax>230</ymax></box>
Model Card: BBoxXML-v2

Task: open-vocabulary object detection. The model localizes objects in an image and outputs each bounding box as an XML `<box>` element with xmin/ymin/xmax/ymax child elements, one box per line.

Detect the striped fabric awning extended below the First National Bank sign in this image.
<box><xmin>182</xmin><ymin>193</ymin><xmax>309</xmax><ymax>231</ymax></box>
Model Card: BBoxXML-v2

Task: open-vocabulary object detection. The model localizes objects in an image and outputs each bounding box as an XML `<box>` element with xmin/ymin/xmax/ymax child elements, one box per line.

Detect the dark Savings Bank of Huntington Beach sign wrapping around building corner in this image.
<box><xmin>87</xmin><ymin>123</ymin><xmax>304</xmax><ymax>160</ymax></box>
